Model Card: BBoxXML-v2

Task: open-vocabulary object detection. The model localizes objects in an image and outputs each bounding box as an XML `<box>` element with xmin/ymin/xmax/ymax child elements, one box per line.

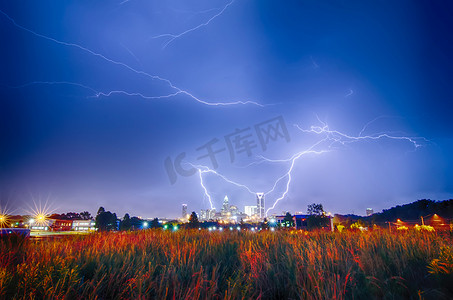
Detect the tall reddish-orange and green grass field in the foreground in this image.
<box><xmin>0</xmin><ymin>230</ymin><xmax>453</xmax><ymax>299</ymax></box>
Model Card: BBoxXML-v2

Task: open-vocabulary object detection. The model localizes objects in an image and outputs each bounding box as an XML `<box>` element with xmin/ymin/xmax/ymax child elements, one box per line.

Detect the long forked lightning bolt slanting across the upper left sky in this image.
<box><xmin>0</xmin><ymin>9</ymin><xmax>264</xmax><ymax>107</ymax></box>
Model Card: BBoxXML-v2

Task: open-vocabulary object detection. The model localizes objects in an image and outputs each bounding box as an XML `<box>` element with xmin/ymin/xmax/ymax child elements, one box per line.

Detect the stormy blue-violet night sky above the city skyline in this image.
<box><xmin>0</xmin><ymin>0</ymin><xmax>453</xmax><ymax>217</ymax></box>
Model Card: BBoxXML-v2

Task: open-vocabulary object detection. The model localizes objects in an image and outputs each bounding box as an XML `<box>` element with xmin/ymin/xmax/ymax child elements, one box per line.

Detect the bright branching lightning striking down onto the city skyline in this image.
<box><xmin>190</xmin><ymin>116</ymin><xmax>429</xmax><ymax>216</ymax></box>
